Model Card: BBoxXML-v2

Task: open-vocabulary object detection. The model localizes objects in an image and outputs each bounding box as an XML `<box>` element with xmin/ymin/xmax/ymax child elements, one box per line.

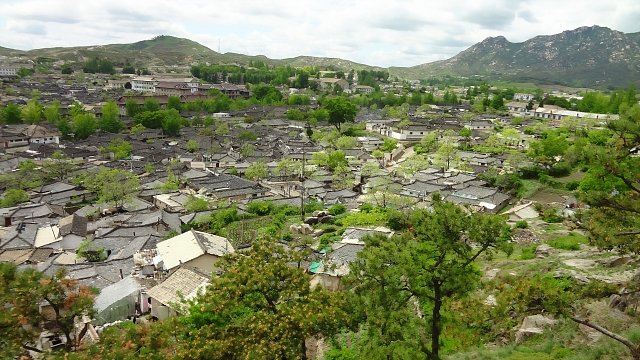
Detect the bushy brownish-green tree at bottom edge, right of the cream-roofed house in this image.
<box><xmin>178</xmin><ymin>241</ymin><xmax>346</xmax><ymax>360</ymax></box>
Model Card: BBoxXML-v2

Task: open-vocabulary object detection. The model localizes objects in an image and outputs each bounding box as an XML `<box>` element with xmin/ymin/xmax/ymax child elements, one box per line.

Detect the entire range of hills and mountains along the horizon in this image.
<box><xmin>0</xmin><ymin>26</ymin><xmax>640</xmax><ymax>88</ymax></box>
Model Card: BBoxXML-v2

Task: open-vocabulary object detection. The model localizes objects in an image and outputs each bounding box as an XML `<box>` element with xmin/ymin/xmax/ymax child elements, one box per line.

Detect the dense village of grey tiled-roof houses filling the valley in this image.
<box><xmin>0</xmin><ymin>57</ymin><xmax>632</xmax><ymax>358</ymax></box>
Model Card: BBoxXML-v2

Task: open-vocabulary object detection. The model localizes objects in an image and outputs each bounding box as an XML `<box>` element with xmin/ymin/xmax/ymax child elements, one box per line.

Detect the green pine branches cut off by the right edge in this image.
<box><xmin>578</xmin><ymin>105</ymin><xmax>640</xmax><ymax>254</ymax></box>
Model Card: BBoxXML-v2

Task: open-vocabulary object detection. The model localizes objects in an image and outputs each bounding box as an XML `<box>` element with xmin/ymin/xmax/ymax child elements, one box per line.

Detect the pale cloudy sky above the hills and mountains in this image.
<box><xmin>0</xmin><ymin>0</ymin><xmax>640</xmax><ymax>67</ymax></box>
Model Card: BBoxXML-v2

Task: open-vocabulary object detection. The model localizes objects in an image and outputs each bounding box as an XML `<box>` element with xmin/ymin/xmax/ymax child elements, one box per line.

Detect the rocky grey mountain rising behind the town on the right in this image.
<box><xmin>400</xmin><ymin>26</ymin><xmax>640</xmax><ymax>88</ymax></box>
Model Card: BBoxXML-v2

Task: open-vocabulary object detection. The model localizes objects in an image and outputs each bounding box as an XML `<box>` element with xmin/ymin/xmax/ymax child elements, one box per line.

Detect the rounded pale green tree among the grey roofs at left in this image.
<box><xmin>85</xmin><ymin>168</ymin><xmax>140</xmax><ymax>209</ymax></box>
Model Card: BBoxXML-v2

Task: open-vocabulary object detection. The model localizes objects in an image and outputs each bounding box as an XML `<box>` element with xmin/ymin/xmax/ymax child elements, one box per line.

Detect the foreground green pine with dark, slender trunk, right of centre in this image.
<box><xmin>346</xmin><ymin>197</ymin><xmax>510</xmax><ymax>359</ymax></box>
